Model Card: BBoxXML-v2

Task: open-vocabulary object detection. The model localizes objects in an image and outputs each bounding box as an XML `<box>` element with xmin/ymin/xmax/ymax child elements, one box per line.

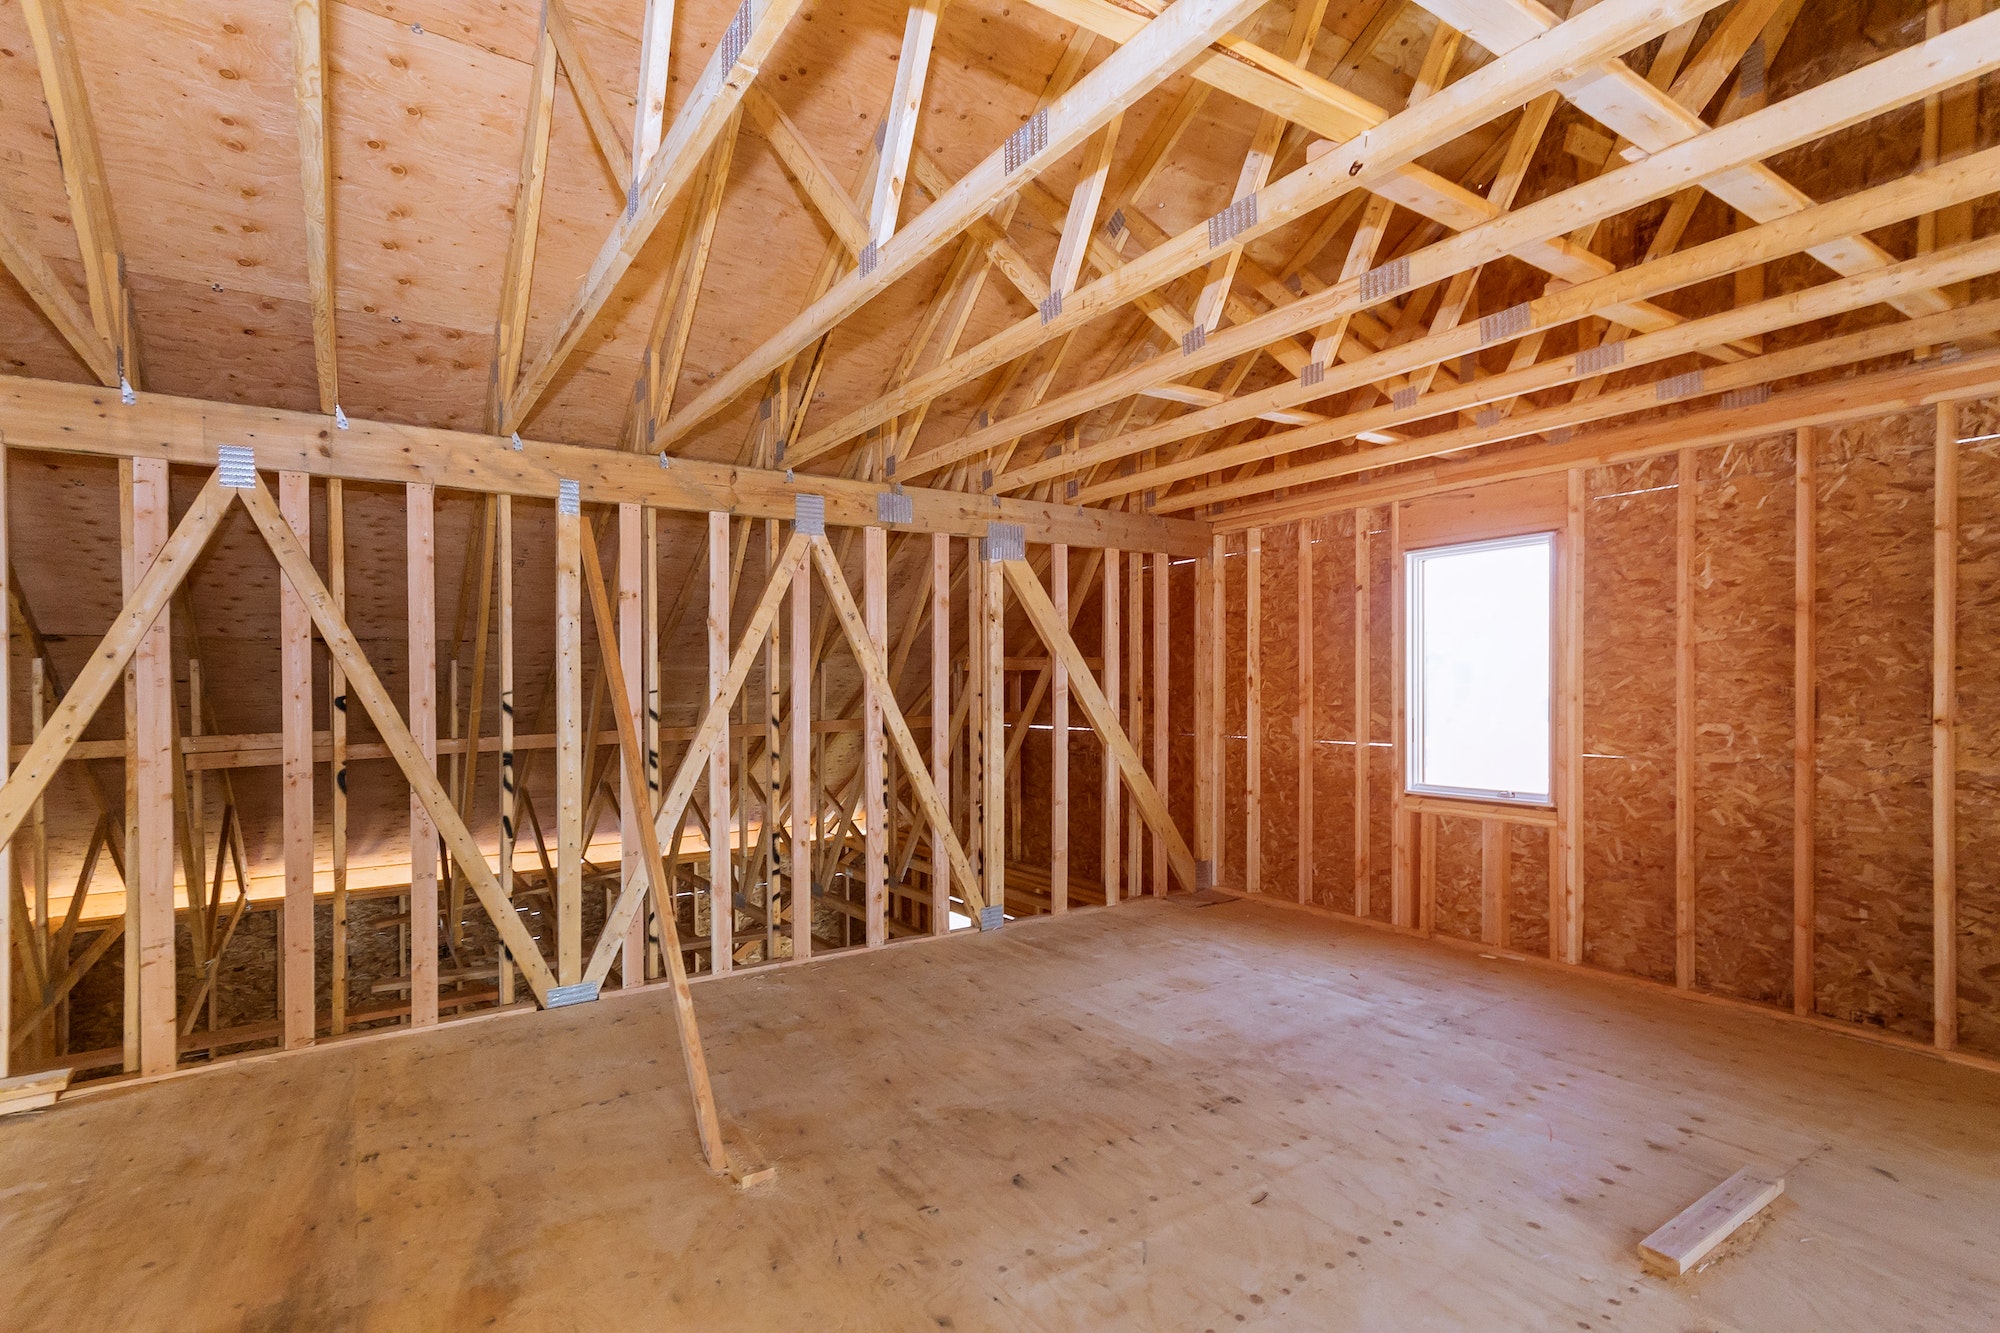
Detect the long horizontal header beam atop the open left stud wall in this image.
<box><xmin>0</xmin><ymin>376</ymin><xmax>1208</xmax><ymax>556</ymax></box>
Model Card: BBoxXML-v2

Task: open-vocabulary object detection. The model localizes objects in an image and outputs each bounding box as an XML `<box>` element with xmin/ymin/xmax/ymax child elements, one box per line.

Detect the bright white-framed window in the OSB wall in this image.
<box><xmin>1404</xmin><ymin>532</ymin><xmax>1556</xmax><ymax>805</ymax></box>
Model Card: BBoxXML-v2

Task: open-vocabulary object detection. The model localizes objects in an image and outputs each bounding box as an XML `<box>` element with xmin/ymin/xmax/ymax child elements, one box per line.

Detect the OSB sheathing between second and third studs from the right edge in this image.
<box><xmin>1694</xmin><ymin>436</ymin><xmax>1792</xmax><ymax>1003</ymax></box>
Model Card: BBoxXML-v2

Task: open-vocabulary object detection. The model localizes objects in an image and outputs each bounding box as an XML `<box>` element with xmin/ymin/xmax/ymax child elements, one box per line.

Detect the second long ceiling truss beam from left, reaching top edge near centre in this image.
<box><xmin>662</xmin><ymin>0</ymin><xmax>1280</xmax><ymax>446</ymax></box>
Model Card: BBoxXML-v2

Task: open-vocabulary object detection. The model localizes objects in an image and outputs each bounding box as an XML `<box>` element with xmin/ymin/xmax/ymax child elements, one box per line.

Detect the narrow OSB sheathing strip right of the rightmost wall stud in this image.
<box><xmin>1956</xmin><ymin>402</ymin><xmax>2000</xmax><ymax>1055</ymax></box>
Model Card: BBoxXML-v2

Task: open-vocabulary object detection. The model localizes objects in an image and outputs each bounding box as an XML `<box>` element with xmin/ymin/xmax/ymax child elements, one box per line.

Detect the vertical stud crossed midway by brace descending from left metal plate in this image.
<box><xmin>404</xmin><ymin>482</ymin><xmax>438</xmax><ymax>1027</ymax></box>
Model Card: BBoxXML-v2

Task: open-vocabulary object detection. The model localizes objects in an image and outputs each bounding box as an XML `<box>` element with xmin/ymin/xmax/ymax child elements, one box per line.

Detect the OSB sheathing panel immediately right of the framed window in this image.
<box><xmin>1584</xmin><ymin>456</ymin><xmax>1678</xmax><ymax>981</ymax></box>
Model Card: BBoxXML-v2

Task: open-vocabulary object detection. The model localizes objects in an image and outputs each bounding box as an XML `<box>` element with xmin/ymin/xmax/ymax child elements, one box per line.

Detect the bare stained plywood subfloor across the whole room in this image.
<box><xmin>0</xmin><ymin>903</ymin><xmax>2000</xmax><ymax>1333</ymax></box>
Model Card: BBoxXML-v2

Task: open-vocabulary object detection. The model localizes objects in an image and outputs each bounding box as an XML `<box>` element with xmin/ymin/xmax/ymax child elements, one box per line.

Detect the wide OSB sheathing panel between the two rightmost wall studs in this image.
<box><xmin>1814</xmin><ymin>412</ymin><xmax>1936</xmax><ymax>1037</ymax></box>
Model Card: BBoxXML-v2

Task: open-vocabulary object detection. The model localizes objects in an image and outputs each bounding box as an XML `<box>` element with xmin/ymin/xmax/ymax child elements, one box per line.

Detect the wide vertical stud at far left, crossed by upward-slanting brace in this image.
<box><xmin>126</xmin><ymin>458</ymin><xmax>180</xmax><ymax>1075</ymax></box>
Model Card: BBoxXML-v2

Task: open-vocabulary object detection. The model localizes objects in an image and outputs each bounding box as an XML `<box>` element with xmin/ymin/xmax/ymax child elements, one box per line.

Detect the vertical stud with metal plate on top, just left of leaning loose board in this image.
<box><xmin>556</xmin><ymin>488</ymin><xmax>588</xmax><ymax>987</ymax></box>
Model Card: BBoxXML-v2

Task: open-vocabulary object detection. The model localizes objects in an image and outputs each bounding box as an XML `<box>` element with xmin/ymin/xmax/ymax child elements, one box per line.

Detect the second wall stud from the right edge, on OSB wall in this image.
<box><xmin>1792</xmin><ymin>426</ymin><xmax>1820</xmax><ymax>1013</ymax></box>
